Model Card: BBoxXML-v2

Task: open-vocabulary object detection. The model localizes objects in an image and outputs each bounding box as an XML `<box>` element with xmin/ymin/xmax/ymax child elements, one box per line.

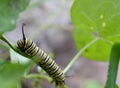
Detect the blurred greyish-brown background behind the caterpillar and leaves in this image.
<box><xmin>0</xmin><ymin>0</ymin><xmax>120</xmax><ymax>88</ymax></box>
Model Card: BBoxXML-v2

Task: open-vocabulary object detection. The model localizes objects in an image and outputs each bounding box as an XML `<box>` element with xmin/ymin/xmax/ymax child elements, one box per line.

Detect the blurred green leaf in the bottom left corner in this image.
<box><xmin>0</xmin><ymin>62</ymin><xmax>28</xmax><ymax>88</ymax></box>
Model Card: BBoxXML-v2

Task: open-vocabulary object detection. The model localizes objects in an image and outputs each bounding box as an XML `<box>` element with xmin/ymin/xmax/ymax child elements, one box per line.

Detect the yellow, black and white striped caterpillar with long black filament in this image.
<box><xmin>17</xmin><ymin>24</ymin><xmax>65</xmax><ymax>85</ymax></box>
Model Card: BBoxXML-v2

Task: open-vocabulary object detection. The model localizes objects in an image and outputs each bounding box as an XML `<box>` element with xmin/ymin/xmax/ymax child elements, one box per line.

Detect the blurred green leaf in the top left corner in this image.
<box><xmin>0</xmin><ymin>0</ymin><xmax>29</xmax><ymax>35</ymax></box>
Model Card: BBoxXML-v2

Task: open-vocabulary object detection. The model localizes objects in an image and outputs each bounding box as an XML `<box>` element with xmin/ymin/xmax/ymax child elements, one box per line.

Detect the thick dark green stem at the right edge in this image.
<box><xmin>105</xmin><ymin>43</ymin><xmax>120</xmax><ymax>88</ymax></box>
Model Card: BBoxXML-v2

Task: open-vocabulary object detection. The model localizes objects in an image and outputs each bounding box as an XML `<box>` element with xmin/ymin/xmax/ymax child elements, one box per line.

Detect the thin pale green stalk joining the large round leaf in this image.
<box><xmin>63</xmin><ymin>38</ymin><xmax>98</xmax><ymax>73</ymax></box>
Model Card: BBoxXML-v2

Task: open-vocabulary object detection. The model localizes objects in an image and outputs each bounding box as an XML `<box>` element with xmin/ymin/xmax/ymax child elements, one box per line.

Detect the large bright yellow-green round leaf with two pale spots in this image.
<box><xmin>71</xmin><ymin>0</ymin><xmax>120</xmax><ymax>61</ymax></box>
